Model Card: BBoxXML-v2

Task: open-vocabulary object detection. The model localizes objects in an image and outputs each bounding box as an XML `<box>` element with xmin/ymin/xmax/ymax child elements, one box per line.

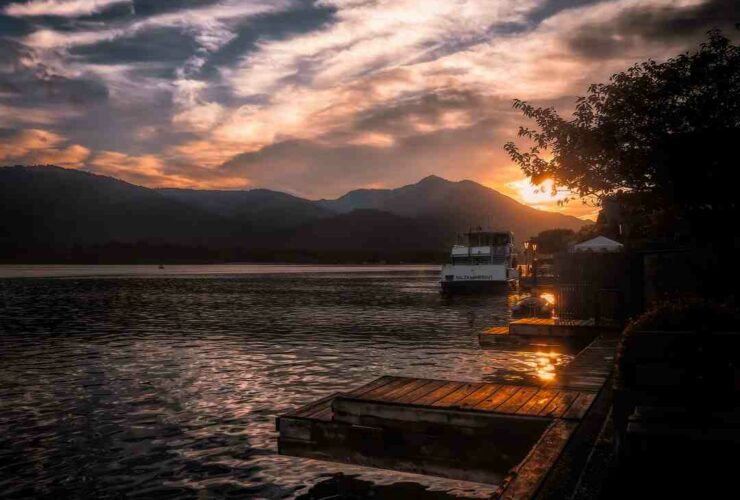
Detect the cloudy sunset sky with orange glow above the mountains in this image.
<box><xmin>0</xmin><ymin>0</ymin><xmax>740</xmax><ymax>217</ymax></box>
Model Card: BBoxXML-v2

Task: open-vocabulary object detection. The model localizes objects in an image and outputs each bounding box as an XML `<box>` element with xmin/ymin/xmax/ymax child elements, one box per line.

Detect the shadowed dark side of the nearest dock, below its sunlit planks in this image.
<box><xmin>278</xmin><ymin>394</ymin><xmax>550</xmax><ymax>484</ymax></box>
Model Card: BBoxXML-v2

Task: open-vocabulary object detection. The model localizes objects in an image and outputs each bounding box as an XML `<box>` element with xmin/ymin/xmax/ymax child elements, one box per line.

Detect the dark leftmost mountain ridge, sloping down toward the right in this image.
<box><xmin>0</xmin><ymin>166</ymin><xmax>231</xmax><ymax>246</ymax></box>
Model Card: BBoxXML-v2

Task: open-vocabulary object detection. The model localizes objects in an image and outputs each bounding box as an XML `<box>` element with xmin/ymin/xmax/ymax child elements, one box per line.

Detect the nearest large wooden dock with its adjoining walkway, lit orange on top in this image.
<box><xmin>277</xmin><ymin>335</ymin><xmax>616</xmax><ymax>488</ymax></box>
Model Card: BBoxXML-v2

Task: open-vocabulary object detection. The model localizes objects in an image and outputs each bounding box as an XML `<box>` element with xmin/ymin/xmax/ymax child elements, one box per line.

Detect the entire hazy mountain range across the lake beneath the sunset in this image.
<box><xmin>0</xmin><ymin>166</ymin><xmax>587</xmax><ymax>262</ymax></box>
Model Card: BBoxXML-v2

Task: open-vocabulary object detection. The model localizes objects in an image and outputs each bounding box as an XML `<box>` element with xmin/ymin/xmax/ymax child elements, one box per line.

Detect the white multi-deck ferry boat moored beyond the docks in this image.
<box><xmin>440</xmin><ymin>228</ymin><xmax>519</xmax><ymax>292</ymax></box>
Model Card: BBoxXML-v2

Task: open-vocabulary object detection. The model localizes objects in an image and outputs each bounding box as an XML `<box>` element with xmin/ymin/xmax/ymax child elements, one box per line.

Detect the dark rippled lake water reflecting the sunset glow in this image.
<box><xmin>0</xmin><ymin>265</ymin><xmax>567</xmax><ymax>498</ymax></box>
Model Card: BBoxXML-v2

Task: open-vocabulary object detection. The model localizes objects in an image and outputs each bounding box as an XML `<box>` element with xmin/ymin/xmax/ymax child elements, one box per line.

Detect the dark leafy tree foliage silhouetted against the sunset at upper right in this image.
<box><xmin>505</xmin><ymin>30</ymin><xmax>740</xmax><ymax>207</ymax></box>
